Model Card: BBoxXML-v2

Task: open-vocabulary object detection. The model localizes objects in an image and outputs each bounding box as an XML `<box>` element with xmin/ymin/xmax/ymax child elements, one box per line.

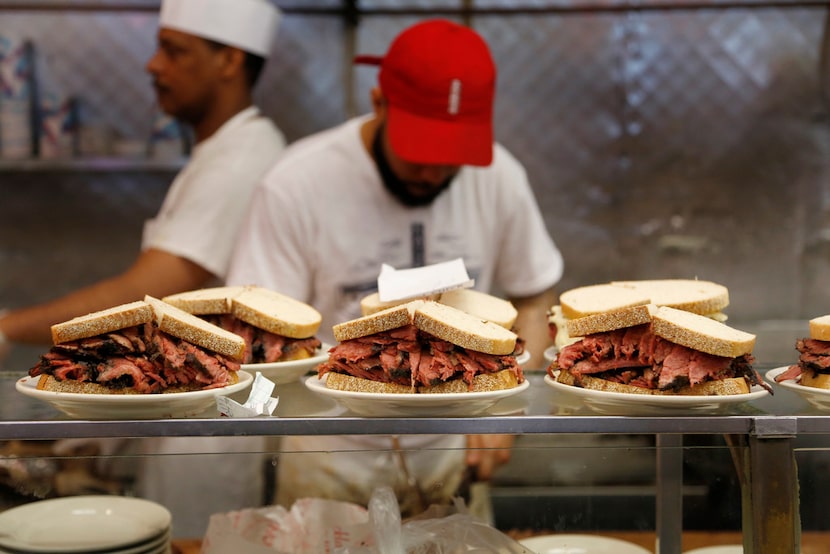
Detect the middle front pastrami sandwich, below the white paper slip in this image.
<box><xmin>317</xmin><ymin>300</ymin><xmax>524</xmax><ymax>393</ymax></box>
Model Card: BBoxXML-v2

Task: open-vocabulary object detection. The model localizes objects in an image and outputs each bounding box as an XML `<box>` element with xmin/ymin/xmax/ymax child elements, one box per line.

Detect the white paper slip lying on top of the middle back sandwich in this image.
<box><xmin>378</xmin><ymin>258</ymin><xmax>475</xmax><ymax>302</ymax></box>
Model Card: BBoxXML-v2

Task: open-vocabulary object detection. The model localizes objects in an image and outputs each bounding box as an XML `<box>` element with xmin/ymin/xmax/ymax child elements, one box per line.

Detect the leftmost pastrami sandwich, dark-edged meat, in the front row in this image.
<box><xmin>29</xmin><ymin>296</ymin><xmax>245</xmax><ymax>394</ymax></box>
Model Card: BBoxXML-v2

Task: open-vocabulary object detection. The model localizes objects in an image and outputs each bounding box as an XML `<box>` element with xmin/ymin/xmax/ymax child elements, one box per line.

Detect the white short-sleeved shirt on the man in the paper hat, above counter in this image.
<box><xmin>141</xmin><ymin>106</ymin><xmax>285</xmax><ymax>278</ymax></box>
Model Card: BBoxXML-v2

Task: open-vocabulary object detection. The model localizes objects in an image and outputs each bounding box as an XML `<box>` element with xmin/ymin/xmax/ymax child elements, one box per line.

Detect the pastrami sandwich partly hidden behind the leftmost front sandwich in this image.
<box><xmin>164</xmin><ymin>286</ymin><xmax>322</xmax><ymax>364</ymax></box>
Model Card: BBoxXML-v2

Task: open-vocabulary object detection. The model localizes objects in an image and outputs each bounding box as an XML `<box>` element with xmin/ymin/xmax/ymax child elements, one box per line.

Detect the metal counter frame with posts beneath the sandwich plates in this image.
<box><xmin>0</xmin><ymin>366</ymin><xmax>830</xmax><ymax>554</ymax></box>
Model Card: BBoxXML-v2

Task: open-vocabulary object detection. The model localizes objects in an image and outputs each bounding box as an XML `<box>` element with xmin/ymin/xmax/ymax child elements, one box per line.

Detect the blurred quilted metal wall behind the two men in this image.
<box><xmin>0</xmin><ymin>0</ymin><xmax>830</xmax><ymax>364</ymax></box>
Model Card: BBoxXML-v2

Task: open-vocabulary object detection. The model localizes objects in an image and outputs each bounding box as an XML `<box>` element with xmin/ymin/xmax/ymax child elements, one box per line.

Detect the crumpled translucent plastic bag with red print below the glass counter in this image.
<box><xmin>202</xmin><ymin>487</ymin><xmax>530</xmax><ymax>554</ymax></box>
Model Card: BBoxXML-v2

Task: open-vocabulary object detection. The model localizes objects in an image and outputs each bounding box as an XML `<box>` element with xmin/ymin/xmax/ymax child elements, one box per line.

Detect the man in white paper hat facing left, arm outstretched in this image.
<box><xmin>0</xmin><ymin>0</ymin><xmax>285</xmax><ymax>536</ymax></box>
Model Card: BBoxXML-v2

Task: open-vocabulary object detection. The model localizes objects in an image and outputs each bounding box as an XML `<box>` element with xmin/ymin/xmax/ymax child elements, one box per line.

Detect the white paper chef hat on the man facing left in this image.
<box><xmin>160</xmin><ymin>0</ymin><xmax>280</xmax><ymax>58</ymax></box>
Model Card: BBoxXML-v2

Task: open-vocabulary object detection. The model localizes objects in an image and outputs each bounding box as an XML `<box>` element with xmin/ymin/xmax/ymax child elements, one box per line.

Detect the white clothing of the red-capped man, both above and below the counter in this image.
<box><xmin>228</xmin><ymin>118</ymin><xmax>563</xmax><ymax>505</ymax></box>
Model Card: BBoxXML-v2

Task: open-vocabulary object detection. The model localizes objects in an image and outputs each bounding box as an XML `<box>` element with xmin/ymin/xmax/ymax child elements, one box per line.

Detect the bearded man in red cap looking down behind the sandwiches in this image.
<box><xmin>228</xmin><ymin>20</ymin><xmax>563</xmax><ymax>504</ymax></box>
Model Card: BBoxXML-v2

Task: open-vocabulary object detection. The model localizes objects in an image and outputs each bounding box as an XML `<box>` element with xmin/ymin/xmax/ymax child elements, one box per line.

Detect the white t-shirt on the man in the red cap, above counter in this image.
<box><xmin>228</xmin><ymin>118</ymin><xmax>563</xmax><ymax>343</ymax></box>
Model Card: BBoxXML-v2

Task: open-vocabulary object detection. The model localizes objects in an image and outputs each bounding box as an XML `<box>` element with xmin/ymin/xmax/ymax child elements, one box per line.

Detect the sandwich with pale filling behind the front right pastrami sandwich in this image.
<box><xmin>548</xmin><ymin>279</ymin><xmax>729</xmax><ymax>348</ymax></box>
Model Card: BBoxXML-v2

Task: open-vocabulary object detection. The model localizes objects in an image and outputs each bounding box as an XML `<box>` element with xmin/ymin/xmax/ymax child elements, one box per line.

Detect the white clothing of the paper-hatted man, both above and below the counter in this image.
<box><xmin>136</xmin><ymin>103</ymin><xmax>285</xmax><ymax>537</ymax></box>
